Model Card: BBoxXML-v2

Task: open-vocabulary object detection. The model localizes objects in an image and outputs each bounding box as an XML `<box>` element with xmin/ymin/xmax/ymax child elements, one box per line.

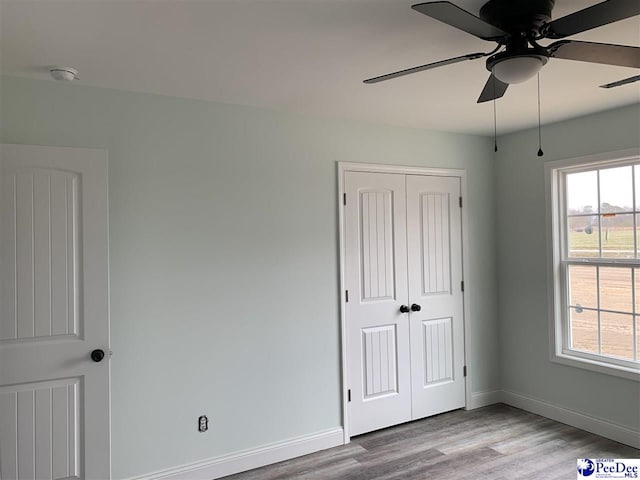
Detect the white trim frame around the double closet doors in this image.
<box><xmin>337</xmin><ymin>162</ymin><xmax>473</xmax><ymax>444</ymax></box>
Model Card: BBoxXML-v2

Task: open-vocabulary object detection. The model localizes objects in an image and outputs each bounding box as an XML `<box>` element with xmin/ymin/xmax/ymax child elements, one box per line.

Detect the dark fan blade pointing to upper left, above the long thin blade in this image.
<box><xmin>411</xmin><ymin>2</ymin><xmax>507</xmax><ymax>40</ymax></box>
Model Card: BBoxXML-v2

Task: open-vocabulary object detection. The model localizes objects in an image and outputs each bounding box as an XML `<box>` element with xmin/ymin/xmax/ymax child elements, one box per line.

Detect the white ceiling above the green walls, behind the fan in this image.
<box><xmin>0</xmin><ymin>0</ymin><xmax>640</xmax><ymax>135</ymax></box>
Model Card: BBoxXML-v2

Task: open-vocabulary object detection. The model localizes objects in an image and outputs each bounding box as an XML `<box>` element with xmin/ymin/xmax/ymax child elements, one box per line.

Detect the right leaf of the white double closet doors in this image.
<box><xmin>407</xmin><ymin>175</ymin><xmax>465</xmax><ymax>419</ymax></box>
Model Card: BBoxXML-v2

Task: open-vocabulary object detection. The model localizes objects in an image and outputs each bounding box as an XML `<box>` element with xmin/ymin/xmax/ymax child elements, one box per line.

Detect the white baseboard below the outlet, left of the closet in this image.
<box><xmin>130</xmin><ymin>427</ymin><xmax>344</xmax><ymax>480</ymax></box>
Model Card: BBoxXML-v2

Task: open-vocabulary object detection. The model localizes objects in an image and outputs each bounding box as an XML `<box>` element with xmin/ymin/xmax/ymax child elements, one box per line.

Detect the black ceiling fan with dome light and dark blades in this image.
<box><xmin>364</xmin><ymin>0</ymin><xmax>640</xmax><ymax>103</ymax></box>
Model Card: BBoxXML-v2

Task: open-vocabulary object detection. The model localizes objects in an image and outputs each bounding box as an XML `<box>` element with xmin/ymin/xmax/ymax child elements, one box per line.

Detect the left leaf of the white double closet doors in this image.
<box><xmin>345</xmin><ymin>172</ymin><xmax>411</xmax><ymax>435</ymax></box>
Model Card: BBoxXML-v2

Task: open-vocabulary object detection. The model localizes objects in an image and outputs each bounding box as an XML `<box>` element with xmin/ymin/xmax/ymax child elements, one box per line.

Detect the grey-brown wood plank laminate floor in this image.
<box><xmin>225</xmin><ymin>404</ymin><xmax>640</xmax><ymax>480</ymax></box>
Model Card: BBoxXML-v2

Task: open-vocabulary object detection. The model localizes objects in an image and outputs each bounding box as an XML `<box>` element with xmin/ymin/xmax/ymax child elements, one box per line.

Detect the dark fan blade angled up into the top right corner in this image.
<box><xmin>540</xmin><ymin>0</ymin><xmax>640</xmax><ymax>38</ymax></box>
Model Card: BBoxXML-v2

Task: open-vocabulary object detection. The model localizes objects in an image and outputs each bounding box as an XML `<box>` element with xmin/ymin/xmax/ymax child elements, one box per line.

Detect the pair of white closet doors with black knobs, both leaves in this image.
<box><xmin>344</xmin><ymin>171</ymin><xmax>465</xmax><ymax>435</ymax></box>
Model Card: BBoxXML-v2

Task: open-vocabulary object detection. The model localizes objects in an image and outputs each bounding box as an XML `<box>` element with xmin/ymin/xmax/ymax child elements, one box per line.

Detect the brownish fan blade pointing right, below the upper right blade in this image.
<box><xmin>547</xmin><ymin>40</ymin><xmax>640</xmax><ymax>68</ymax></box>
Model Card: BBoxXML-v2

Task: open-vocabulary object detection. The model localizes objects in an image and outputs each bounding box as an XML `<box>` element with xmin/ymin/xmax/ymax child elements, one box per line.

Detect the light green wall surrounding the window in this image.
<box><xmin>495</xmin><ymin>105</ymin><xmax>640</xmax><ymax>429</ymax></box>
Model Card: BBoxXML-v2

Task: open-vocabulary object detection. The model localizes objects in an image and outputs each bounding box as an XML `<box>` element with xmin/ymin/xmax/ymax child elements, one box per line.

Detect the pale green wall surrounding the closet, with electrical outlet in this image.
<box><xmin>0</xmin><ymin>77</ymin><xmax>499</xmax><ymax>478</ymax></box>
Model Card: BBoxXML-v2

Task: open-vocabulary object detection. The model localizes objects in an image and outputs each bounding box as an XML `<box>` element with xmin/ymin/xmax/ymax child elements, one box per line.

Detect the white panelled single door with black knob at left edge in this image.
<box><xmin>0</xmin><ymin>145</ymin><xmax>110</xmax><ymax>480</ymax></box>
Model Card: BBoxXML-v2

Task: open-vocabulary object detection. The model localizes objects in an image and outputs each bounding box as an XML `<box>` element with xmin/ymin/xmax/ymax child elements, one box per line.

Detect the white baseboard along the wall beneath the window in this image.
<box><xmin>501</xmin><ymin>390</ymin><xmax>640</xmax><ymax>448</ymax></box>
